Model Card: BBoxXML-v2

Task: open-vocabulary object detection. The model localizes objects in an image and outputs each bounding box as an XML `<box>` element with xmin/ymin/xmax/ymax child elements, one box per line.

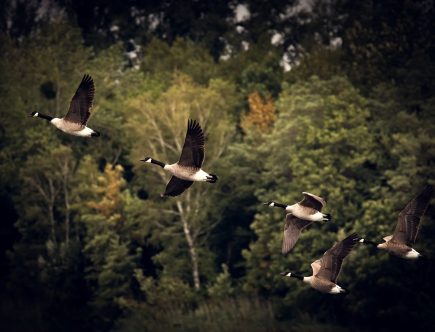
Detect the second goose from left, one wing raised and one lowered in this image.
<box><xmin>141</xmin><ymin>120</ymin><xmax>218</xmax><ymax>196</ymax></box>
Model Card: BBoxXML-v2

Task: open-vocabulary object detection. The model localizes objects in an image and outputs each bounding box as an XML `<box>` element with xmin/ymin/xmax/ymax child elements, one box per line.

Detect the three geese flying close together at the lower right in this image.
<box><xmin>272</xmin><ymin>185</ymin><xmax>433</xmax><ymax>294</ymax></box>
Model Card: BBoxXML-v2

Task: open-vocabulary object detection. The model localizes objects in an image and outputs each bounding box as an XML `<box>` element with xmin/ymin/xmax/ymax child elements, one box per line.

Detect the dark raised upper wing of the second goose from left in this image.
<box><xmin>178</xmin><ymin>120</ymin><xmax>205</xmax><ymax>168</ymax></box>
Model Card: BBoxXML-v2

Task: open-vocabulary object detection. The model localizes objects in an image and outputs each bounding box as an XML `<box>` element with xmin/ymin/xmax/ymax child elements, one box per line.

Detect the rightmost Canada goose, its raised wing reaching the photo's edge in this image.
<box><xmin>360</xmin><ymin>185</ymin><xmax>433</xmax><ymax>259</ymax></box>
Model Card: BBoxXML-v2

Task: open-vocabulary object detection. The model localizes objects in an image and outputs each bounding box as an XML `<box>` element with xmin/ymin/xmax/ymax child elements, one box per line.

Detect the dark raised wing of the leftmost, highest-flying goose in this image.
<box><xmin>64</xmin><ymin>74</ymin><xmax>95</xmax><ymax>126</ymax></box>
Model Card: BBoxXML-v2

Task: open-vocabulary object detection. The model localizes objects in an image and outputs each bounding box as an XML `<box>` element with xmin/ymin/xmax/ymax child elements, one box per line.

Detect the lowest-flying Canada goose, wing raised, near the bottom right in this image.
<box><xmin>281</xmin><ymin>233</ymin><xmax>361</xmax><ymax>294</ymax></box>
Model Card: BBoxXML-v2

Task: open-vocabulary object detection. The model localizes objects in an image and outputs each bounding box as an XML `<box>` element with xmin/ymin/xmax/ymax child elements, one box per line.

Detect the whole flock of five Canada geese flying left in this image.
<box><xmin>30</xmin><ymin>75</ymin><xmax>433</xmax><ymax>294</ymax></box>
